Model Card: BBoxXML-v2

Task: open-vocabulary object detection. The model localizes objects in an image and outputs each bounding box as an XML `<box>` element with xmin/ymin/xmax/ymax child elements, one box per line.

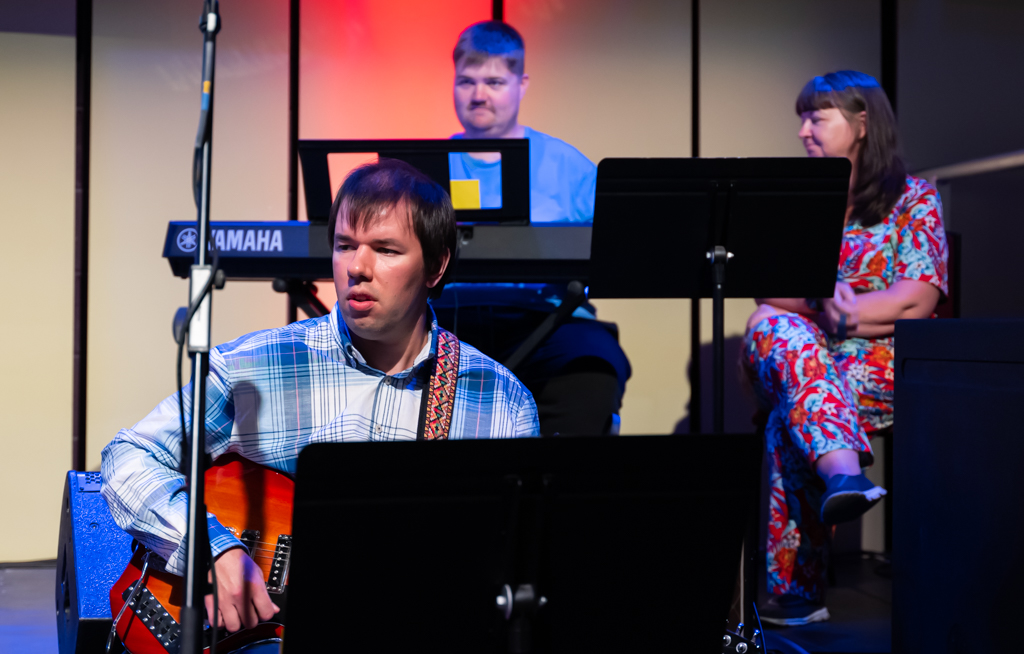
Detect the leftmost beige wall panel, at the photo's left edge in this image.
<box><xmin>0</xmin><ymin>32</ymin><xmax>75</xmax><ymax>561</ymax></box>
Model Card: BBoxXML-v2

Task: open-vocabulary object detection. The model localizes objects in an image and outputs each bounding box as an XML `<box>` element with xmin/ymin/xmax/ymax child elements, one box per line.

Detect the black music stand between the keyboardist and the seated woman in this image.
<box><xmin>590</xmin><ymin>158</ymin><xmax>850</xmax><ymax>433</ymax></box>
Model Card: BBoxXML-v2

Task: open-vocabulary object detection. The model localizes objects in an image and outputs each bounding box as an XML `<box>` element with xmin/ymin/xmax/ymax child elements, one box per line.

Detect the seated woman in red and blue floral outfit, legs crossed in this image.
<box><xmin>743</xmin><ymin>71</ymin><xmax>947</xmax><ymax>625</ymax></box>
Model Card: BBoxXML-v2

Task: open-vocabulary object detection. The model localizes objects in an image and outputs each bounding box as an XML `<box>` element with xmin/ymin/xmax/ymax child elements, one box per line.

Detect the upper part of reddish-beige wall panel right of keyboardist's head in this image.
<box><xmin>505</xmin><ymin>0</ymin><xmax>690</xmax><ymax>163</ymax></box>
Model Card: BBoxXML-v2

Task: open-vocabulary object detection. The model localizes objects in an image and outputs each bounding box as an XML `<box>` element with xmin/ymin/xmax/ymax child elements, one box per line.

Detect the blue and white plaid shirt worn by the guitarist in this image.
<box><xmin>102</xmin><ymin>305</ymin><xmax>540</xmax><ymax>574</ymax></box>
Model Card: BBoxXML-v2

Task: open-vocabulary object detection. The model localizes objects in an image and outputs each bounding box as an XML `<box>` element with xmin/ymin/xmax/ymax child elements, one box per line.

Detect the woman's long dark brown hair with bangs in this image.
<box><xmin>797</xmin><ymin>71</ymin><xmax>906</xmax><ymax>227</ymax></box>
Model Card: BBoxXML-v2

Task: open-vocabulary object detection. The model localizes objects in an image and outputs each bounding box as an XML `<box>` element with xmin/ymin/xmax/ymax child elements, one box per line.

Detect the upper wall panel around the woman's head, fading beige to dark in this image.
<box><xmin>700</xmin><ymin>0</ymin><xmax>882</xmax><ymax>157</ymax></box>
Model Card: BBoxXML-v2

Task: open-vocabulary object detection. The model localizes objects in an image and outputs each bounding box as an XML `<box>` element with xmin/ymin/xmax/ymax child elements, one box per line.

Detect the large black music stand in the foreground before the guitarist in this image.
<box><xmin>285</xmin><ymin>436</ymin><xmax>762</xmax><ymax>654</ymax></box>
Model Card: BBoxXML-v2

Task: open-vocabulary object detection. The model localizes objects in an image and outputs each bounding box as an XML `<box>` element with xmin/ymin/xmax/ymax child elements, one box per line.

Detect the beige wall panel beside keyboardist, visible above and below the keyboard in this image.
<box><xmin>505</xmin><ymin>0</ymin><xmax>690</xmax><ymax>434</ymax></box>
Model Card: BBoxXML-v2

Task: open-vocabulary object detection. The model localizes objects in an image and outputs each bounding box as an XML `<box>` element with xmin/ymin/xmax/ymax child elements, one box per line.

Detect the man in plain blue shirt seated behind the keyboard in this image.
<box><xmin>433</xmin><ymin>20</ymin><xmax>631</xmax><ymax>435</ymax></box>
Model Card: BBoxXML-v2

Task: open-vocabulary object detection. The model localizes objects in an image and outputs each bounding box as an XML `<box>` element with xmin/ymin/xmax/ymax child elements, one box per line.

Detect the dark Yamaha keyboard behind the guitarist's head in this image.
<box><xmin>164</xmin><ymin>220</ymin><xmax>591</xmax><ymax>284</ymax></box>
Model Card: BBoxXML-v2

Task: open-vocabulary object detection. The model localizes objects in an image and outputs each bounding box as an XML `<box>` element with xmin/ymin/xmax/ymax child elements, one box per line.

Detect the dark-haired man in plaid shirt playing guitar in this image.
<box><xmin>102</xmin><ymin>160</ymin><xmax>540</xmax><ymax>631</ymax></box>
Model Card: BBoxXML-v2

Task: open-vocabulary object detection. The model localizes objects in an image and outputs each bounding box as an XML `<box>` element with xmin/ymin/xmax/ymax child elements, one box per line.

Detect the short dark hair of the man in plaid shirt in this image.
<box><xmin>327</xmin><ymin>158</ymin><xmax>456</xmax><ymax>298</ymax></box>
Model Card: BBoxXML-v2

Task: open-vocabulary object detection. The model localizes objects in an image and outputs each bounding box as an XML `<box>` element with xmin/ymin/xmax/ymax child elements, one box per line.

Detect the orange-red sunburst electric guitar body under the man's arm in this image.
<box><xmin>111</xmin><ymin>454</ymin><xmax>295</xmax><ymax>654</ymax></box>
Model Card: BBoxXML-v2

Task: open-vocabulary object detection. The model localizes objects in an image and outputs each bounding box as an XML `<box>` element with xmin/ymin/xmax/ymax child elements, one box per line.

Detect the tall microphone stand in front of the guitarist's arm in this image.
<box><xmin>179</xmin><ymin>0</ymin><xmax>220</xmax><ymax>654</ymax></box>
